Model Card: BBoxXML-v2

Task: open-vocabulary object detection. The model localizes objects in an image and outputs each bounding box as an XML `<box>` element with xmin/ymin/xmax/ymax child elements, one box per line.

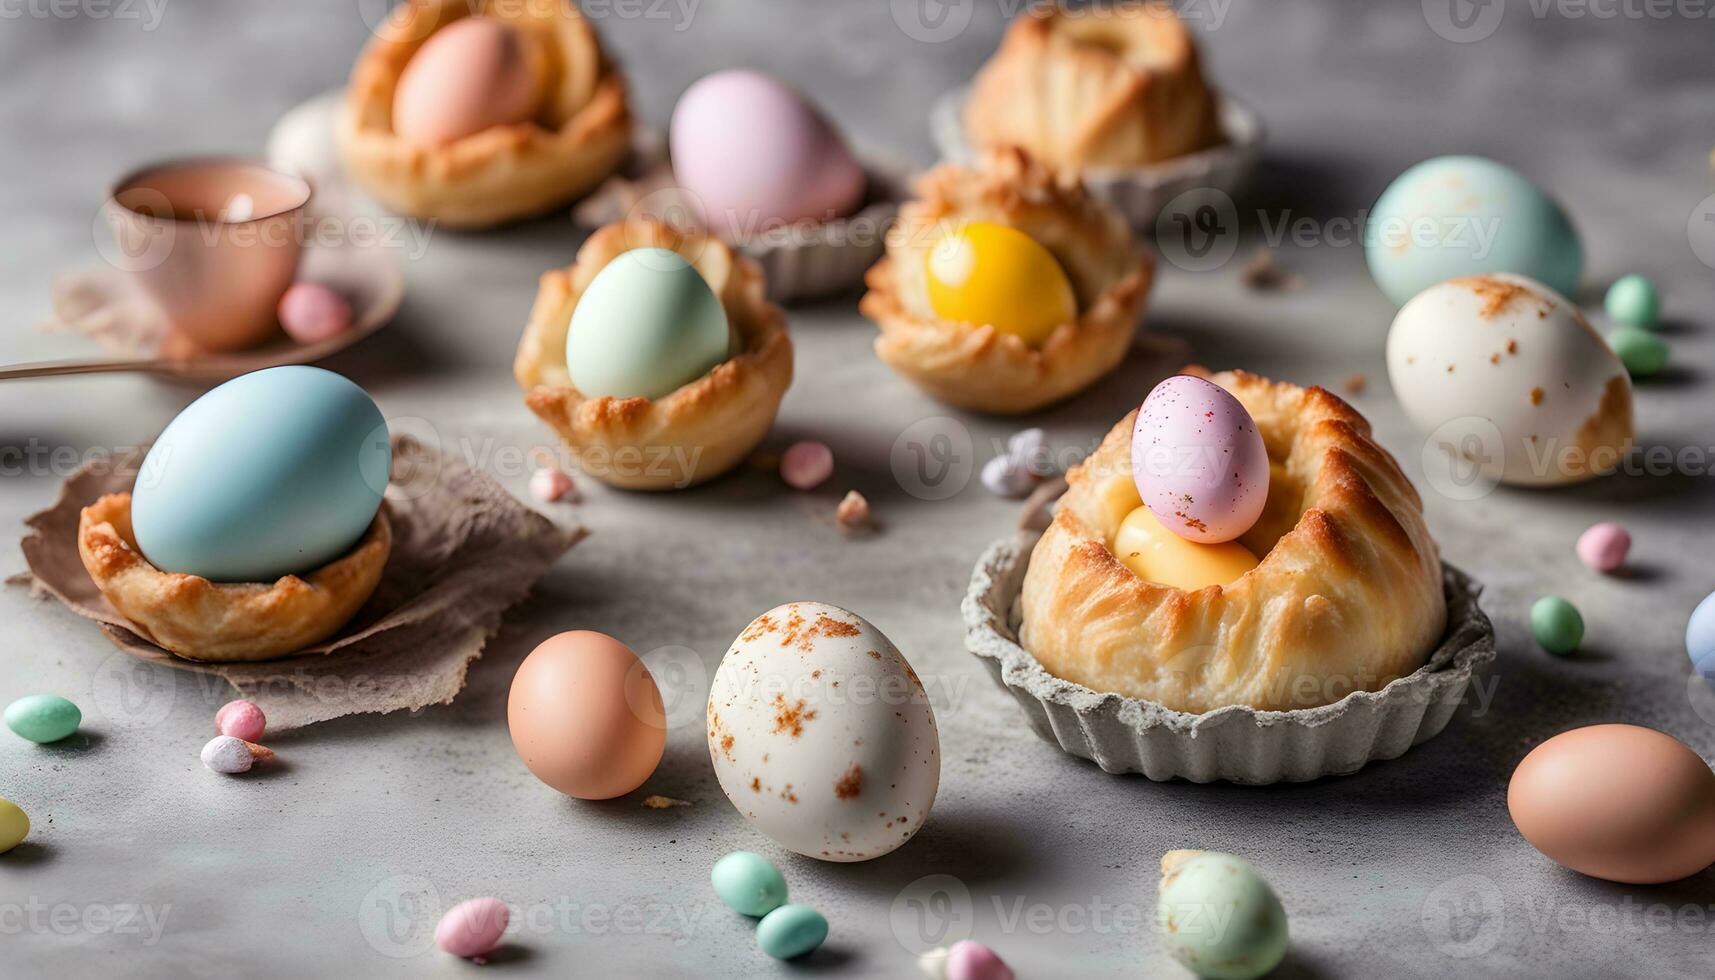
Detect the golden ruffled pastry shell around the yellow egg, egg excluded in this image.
<box><xmin>859</xmin><ymin>149</ymin><xmax>1154</xmax><ymax>414</ymax></box>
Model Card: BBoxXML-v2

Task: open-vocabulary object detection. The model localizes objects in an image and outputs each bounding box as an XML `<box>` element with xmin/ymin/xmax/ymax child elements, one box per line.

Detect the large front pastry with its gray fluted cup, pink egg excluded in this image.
<box><xmin>964</xmin><ymin>369</ymin><xmax>1495</xmax><ymax>784</ymax></box>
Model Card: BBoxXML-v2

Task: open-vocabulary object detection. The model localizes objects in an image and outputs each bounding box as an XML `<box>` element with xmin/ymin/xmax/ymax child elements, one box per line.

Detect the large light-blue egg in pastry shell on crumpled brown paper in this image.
<box><xmin>130</xmin><ymin>366</ymin><xmax>393</xmax><ymax>582</ymax></box>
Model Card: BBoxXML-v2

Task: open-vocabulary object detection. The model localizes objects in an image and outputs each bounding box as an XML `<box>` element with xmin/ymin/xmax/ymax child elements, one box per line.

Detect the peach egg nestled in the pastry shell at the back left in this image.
<box><xmin>393</xmin><ymin>17</ymin><xmax>542</xmax><ymax>146</ymax></box>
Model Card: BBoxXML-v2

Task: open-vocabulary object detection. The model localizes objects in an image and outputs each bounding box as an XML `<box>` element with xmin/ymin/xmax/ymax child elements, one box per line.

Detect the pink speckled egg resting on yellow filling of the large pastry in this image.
<box><xmin>1132</xmin><ymin>374</ymin><xmax>1269</xmax><ymax>544</ymax></box>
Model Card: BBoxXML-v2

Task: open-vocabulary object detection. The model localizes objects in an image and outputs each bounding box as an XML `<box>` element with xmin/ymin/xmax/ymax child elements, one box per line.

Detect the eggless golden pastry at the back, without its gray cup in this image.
<box><xmin>964</xmin><ymin>3</ymin><xmax>1223</xmax><ymax>170</ymax></box>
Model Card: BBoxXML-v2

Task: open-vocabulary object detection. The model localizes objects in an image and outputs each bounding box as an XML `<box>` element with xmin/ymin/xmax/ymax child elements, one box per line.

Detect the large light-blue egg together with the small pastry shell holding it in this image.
<box><xmin>77</xmin><ymin>366</ymin><xmax>393</xmax><ymax>662</ymax></box>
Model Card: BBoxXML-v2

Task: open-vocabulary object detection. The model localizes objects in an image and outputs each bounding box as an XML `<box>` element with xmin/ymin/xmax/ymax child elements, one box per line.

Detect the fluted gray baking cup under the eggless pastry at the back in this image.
<box><xmin>930</xmin><ymin>86</ymin><xmax>1264</xmax><ymax>233</ymax></box>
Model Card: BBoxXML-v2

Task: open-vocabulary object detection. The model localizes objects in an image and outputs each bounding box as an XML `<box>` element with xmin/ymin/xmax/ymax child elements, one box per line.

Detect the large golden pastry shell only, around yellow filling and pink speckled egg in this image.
<box><xmin>1019</xmin><ymin>369</ymin><xmax>1447</xmax><ymax>712</ymax></box>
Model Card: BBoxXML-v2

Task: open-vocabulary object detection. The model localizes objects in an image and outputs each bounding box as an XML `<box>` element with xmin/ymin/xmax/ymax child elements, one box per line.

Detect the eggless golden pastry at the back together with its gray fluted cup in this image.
<box><xmin>931</xmin><ymin>2</ymin><xmax>1262</xmax><ymax>228</ymax></box>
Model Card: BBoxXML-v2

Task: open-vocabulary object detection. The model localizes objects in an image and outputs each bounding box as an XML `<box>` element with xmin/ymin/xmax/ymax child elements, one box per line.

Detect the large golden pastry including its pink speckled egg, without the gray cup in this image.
<box><xmin>1019</xmin><ymin>367</ymin><xmax>1447</xmax><ymax>714</ymax></box>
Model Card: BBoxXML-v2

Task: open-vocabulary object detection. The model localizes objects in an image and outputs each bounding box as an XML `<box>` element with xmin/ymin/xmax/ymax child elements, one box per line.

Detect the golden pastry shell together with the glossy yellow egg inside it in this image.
<box><xmin>859</xmin><ymin>149</ymin><xmax>1154</xmax><ymax>414</ymax></box>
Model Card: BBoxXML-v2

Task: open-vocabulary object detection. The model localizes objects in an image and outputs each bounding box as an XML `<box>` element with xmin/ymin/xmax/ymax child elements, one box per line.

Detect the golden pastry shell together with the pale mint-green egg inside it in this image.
<box><xmin>513</xmin><ymin>218</ymin><xmax>792</xmax><ymax>491</ymax></box>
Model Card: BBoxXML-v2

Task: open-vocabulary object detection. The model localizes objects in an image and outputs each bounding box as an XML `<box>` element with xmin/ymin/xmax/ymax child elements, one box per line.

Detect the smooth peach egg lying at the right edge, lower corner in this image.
<box><xmin>1506</xmin><ymin>724</ymin><xmax>1715</xmax><ymax>884</ymax></box>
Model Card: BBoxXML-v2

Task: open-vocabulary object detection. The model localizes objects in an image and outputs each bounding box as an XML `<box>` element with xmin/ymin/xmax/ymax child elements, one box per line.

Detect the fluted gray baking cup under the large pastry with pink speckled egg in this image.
<box><xmin>962</xmin><ymin>530</ymin><xmax>1495</xmax><ymax>786</ymax></box>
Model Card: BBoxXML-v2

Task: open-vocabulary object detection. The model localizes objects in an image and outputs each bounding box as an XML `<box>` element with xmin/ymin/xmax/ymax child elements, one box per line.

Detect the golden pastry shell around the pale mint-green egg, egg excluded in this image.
<box><xmin>513</xmin><ymin>220</ymin><xmax>792</xmax><ymax>491</ymax></box>
